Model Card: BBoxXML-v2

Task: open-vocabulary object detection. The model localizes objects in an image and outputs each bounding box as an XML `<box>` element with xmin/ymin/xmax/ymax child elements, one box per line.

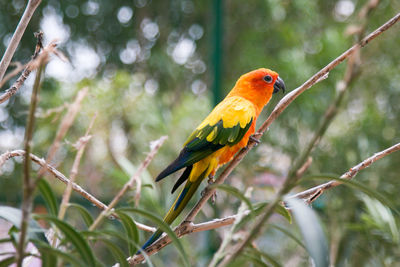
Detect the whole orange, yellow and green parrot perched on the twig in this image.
<box><xmin>142</xmin><ymin>68</ymin><xmax>285</xmax><ymax>252</ymax></box>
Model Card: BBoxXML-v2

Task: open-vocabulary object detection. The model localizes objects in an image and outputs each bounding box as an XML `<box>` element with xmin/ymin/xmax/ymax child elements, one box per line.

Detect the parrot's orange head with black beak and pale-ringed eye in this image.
<box><xmin>228</xmin><ymin>68</ymin><xmax>285</xmax><ymax>111</ymax></box>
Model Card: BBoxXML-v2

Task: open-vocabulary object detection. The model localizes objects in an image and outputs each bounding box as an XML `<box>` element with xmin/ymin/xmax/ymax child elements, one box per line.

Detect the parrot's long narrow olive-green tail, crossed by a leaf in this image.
<box><xmin>138</xmin><ymin>172</ymin><xmax>205</xmax><ymax>254</ymax></box>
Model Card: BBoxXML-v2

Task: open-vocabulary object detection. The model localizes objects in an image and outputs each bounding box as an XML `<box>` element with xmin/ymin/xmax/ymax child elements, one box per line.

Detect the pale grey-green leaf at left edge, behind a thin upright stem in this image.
<box><xmin>0</xmin><ymin>206</ymin><xmax>48</xmax><ymax>242</ymax></box>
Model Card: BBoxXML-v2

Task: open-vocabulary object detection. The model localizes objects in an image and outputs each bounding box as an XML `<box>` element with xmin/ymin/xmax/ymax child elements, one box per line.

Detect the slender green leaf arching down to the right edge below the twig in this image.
<box><xmin>302</xmin><ymin>174</ymin><xmax>400</xmax><ymax>215</ymax></box>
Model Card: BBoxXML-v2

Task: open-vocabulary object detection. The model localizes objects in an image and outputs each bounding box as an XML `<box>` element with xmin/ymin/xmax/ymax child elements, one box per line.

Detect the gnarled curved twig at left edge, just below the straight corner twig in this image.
<box><xmin>0</xmin><ymin>32</ymin><xmax>43</xmax><ymax>104</ymax></box>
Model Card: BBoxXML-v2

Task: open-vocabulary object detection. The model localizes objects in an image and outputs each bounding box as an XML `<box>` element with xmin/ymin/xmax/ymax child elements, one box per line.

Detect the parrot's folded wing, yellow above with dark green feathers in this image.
<box><xmin>156</xmin><ymin>96</ymin><xmax>256</xmax><ymax>181</ymax></box>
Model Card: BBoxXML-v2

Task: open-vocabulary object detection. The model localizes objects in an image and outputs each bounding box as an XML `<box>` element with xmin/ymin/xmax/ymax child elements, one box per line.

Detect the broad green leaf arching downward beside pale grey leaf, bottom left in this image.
<box><xmin>35</xmin><ymin>215</ymin><xmax>96</xmax><ymax>266</ymax></box>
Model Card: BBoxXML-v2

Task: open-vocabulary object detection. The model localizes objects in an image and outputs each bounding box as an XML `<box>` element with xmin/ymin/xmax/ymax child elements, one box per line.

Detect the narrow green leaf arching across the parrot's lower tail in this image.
<box><xmin>118</xmin><ymin>208</ymin><xmax>190</xmax><ymax>266</ymax></box>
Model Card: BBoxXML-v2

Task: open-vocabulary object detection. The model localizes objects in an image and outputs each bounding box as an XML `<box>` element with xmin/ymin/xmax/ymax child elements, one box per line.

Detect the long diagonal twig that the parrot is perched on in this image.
<box><xmin>129</xmin><ymin>13</ymin><xmax>400</xmax><ymax>265</ymax></box>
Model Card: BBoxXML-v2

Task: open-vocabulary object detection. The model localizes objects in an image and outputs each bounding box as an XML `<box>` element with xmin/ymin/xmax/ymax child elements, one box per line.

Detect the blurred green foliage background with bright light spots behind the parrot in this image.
<box><xmin>0</xmin><ymin>0</ymin><xmax>400</xmax><ymax>266</ymax></box>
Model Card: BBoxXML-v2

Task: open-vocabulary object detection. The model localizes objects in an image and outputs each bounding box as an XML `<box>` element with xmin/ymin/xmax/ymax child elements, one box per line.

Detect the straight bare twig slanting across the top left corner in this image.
<box><xmin>0</xmin><ymin>0</ymin><xmax>41</xmax><ymax>81</ymax></box>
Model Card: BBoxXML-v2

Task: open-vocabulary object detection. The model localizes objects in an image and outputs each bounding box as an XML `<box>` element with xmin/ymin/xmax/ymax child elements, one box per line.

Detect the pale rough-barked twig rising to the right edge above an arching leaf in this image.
<box><xmin>290</xmin><ymin>143</ymin><xmax>400</xmax><ymax>204</ymax></box>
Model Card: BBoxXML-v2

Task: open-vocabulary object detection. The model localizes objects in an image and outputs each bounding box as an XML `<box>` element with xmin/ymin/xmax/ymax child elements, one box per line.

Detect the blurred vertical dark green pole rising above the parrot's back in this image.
<box><xmin>211</xmin><ymin>0</ymin><xmax>223</xmax><ymax>105</ymax></box>
